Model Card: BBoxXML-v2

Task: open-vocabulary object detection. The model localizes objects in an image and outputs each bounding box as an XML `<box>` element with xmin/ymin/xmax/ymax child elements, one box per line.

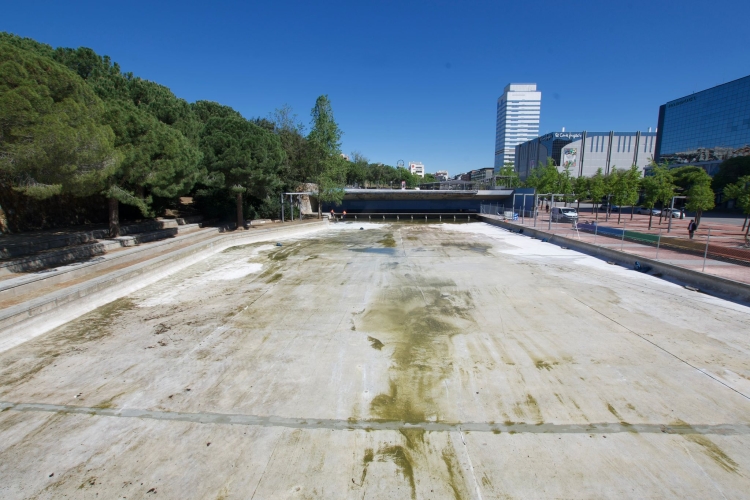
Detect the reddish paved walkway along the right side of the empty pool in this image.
<box><xmin>496</xmin><ymin>213</ymin><xmax>750</xmax><ymax>284</ymax></box>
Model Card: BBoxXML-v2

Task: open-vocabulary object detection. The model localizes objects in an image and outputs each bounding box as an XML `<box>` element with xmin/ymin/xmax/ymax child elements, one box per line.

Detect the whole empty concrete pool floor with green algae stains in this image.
<box><xmin>0</xmin><ymin>223</ymin><xmax>750</xmax><ymax>499</ymax></box>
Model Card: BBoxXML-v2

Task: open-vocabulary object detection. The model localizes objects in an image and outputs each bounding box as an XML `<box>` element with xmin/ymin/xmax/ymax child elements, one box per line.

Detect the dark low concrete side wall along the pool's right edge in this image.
<box><xmin>477</xmin><ymin>215</ymin><xmax>750</xmax><ymax>303</ymax></box>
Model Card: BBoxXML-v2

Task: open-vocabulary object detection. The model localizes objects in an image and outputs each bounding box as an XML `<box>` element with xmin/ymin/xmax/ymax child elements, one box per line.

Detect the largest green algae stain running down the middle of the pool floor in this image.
<box><xmin>354</xmin><ymin>229</ymin><xmax>476</xmax><ymax>498</ymax></box>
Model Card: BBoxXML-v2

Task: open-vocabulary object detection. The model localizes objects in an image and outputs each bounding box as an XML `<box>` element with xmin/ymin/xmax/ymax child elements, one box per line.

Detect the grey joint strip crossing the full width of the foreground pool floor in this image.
<box><xmin>0</xmin><ymin>401</ymin><xmax>750</xmax><ymax>439</ymax></box>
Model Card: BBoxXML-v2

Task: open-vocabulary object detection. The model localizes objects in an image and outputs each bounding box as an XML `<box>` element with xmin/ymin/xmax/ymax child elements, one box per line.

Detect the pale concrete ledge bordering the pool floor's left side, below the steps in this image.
<box><xmin>0</xmin><ymin>220</ymin><xmax>328</xmax><ymax>352</ymax></box>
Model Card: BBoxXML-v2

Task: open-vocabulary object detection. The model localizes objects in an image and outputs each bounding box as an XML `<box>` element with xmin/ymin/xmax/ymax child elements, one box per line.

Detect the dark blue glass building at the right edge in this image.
<box><xmin>654</xmin><ymin>76</ymin><xmax>750</xmax><ymax>174</ymax></box>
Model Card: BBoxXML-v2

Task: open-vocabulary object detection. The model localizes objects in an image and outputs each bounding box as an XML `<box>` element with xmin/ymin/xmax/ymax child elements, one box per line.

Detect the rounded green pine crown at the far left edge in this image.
<box><xmin>0</xmin><ymin>40</ymin><xmax>118</xmax><ymax>198</ymax></box>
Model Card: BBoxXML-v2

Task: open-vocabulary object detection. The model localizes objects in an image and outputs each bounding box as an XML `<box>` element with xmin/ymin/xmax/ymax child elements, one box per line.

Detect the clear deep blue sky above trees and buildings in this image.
<box><xmin>0</xmin><ymin>0</ymin><xmax>750</xmax><ymax>174</ymax></box>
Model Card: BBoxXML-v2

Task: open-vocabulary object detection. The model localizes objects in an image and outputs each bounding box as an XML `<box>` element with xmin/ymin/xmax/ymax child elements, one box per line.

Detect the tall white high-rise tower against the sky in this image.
<box><xmin>495</xmin><ymin>83</ymin><xmax>542</xmax><ymax>172</ymax></box>
